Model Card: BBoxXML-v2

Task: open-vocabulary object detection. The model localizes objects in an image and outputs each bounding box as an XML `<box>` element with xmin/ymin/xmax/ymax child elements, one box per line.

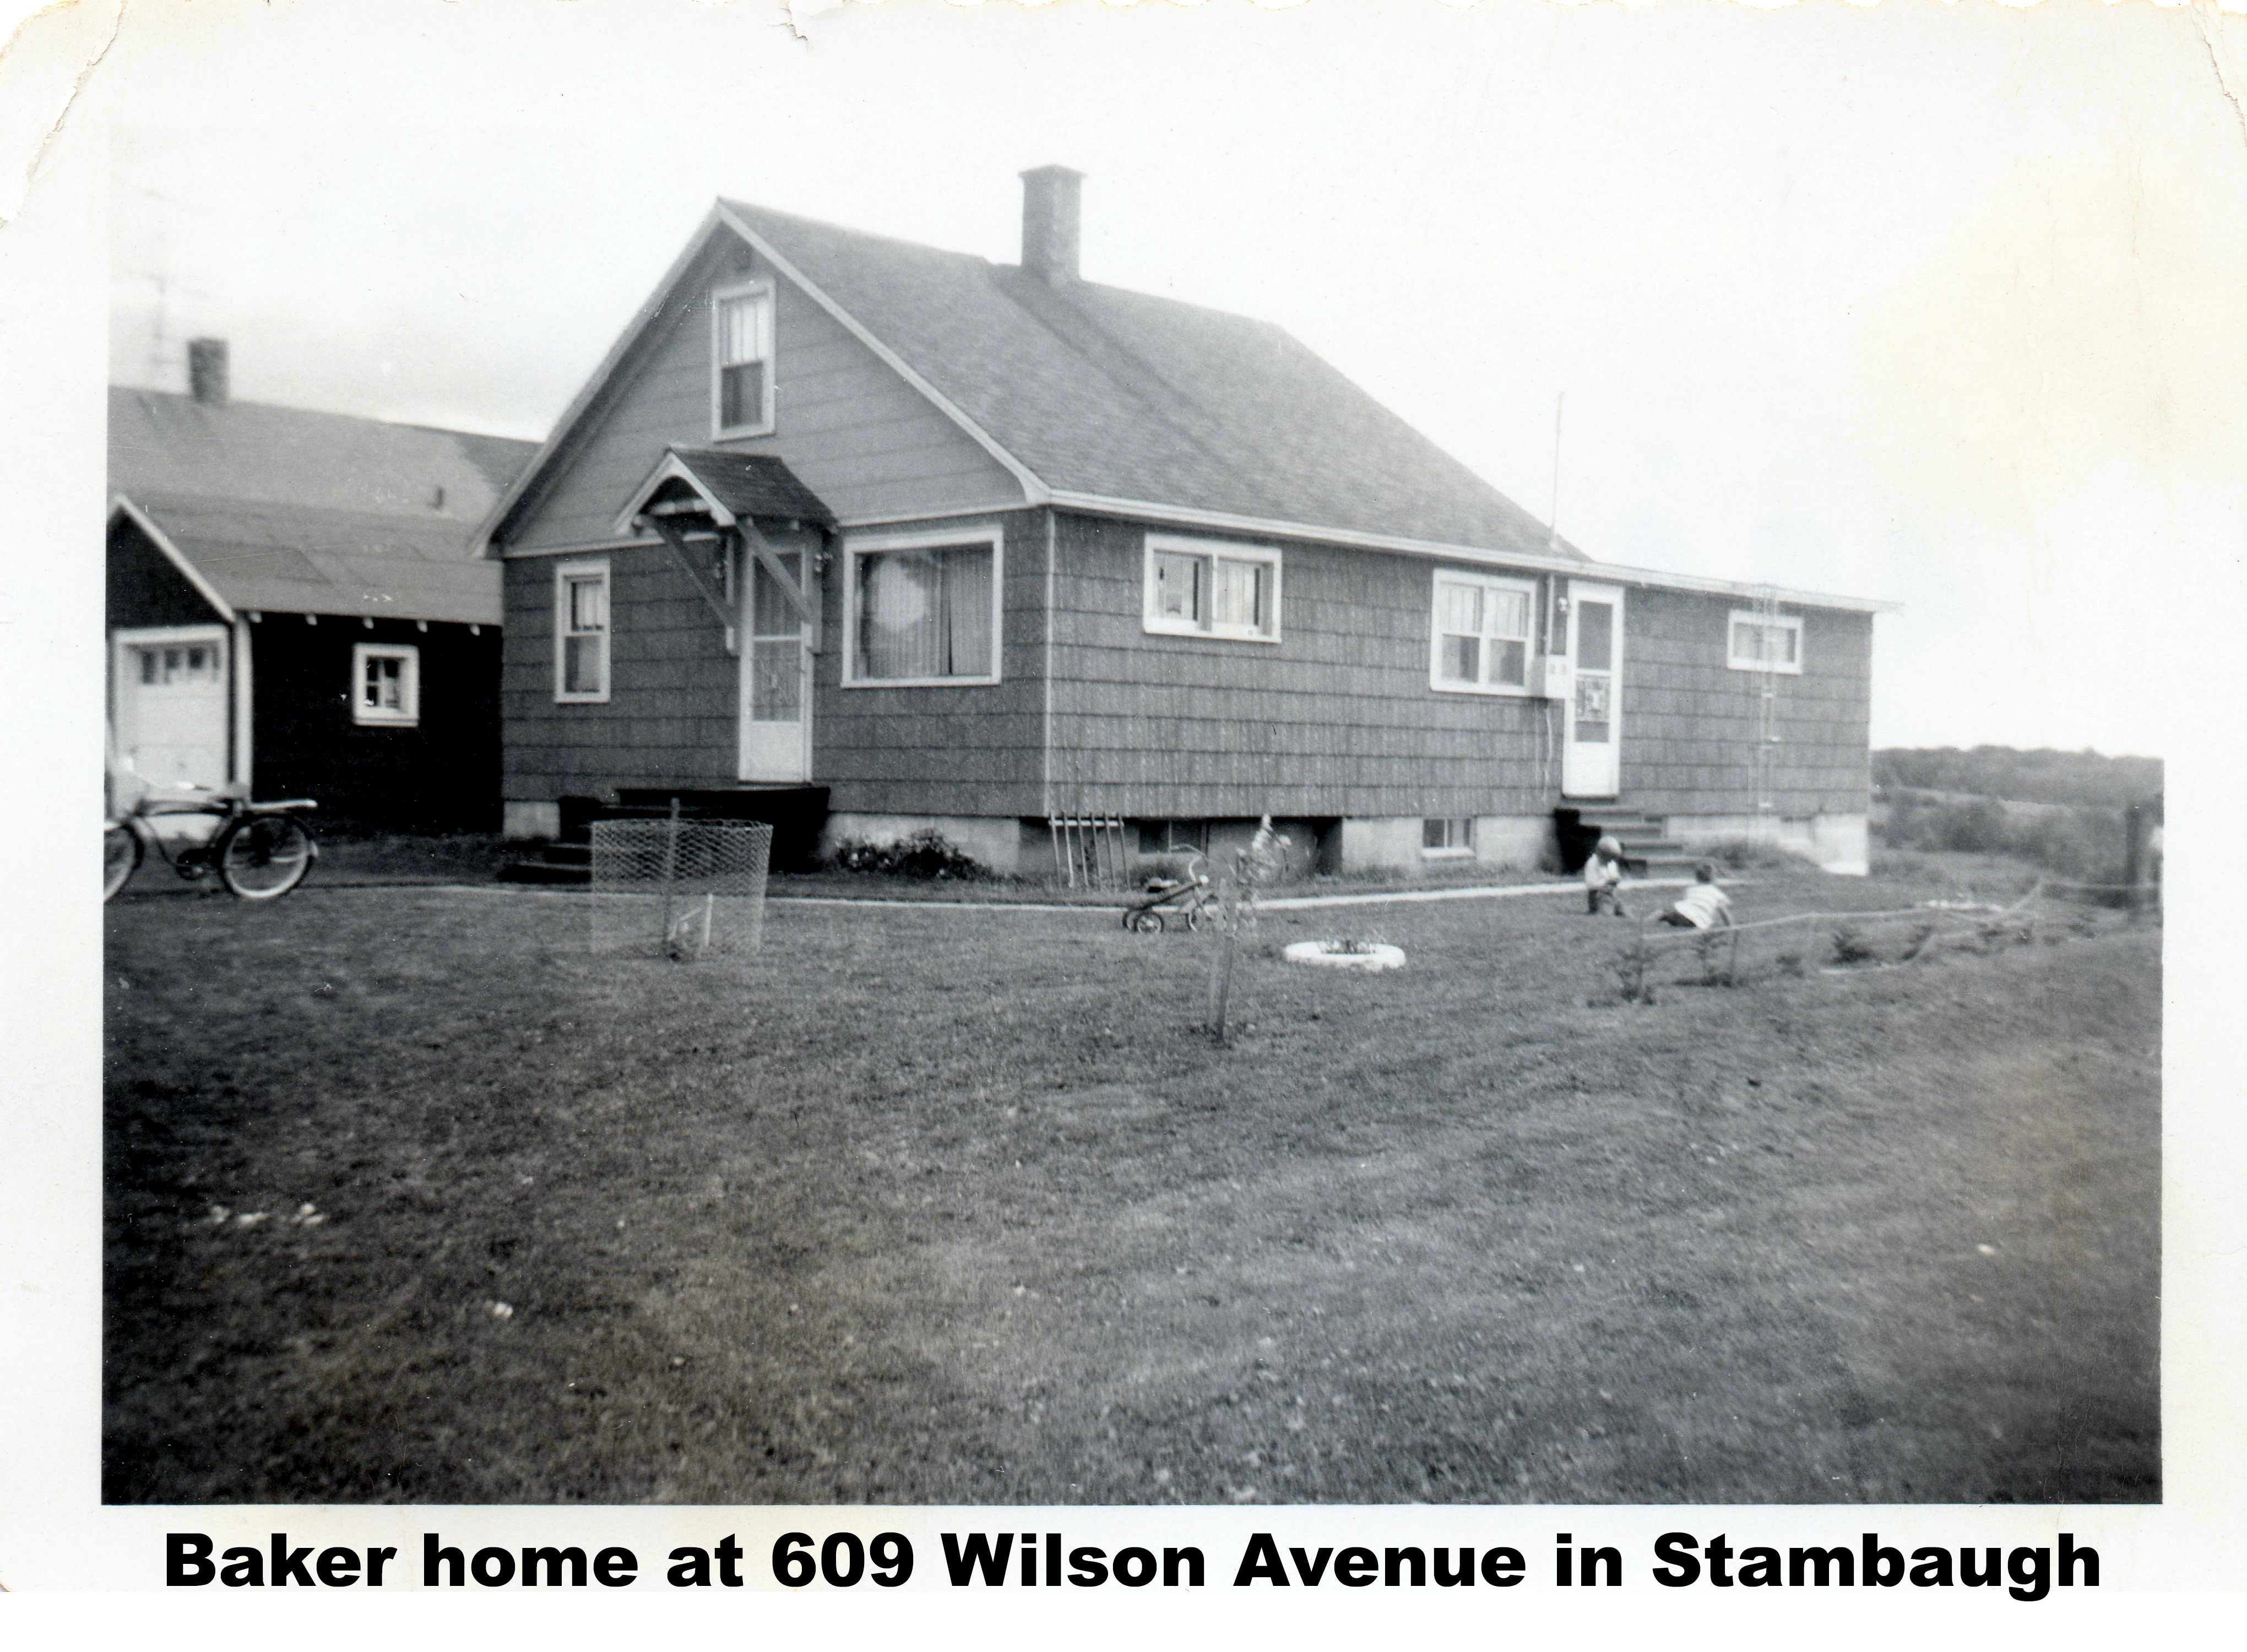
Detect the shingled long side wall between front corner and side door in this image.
<box><xmin>1054</xmin><ymin>515</ymin><xmax>1560</xmax><ymax>818</ymax></box>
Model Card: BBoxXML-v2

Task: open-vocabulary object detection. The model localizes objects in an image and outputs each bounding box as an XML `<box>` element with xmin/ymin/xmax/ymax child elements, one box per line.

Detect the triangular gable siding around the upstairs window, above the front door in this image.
<box><xmin>508</xmin><ymin>238</ymin><xmax>1022</xmax><ymax>548</ymax></box>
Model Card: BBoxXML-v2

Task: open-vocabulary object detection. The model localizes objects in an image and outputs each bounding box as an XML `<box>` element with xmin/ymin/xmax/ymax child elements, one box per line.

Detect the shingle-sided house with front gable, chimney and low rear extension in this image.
<box><xmin>483</xmin><ymin>166</ymin><xmax>1881</xmax><ymax>872</ymax></box>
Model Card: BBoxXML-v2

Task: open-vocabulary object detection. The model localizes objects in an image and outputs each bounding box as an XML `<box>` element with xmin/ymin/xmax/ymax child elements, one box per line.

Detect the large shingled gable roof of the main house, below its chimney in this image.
<box><xmin>485</xmin><ymin>200</ymin><xmax>1584</xmax><ymax>562</ymax></box>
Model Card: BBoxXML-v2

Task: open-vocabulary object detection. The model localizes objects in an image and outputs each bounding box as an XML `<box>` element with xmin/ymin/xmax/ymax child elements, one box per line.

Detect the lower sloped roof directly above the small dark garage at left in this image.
<box><xmin>112</xmin><ymin>494</ymin><xmax>501</xmax><ymax>625</ymax></box>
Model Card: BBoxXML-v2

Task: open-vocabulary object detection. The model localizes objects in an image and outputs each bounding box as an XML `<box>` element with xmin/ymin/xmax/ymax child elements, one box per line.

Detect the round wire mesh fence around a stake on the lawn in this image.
<box><xmin>591</xmin><ymin>816</ymin><xmax>773</xmax><ymax>960</ymax></box>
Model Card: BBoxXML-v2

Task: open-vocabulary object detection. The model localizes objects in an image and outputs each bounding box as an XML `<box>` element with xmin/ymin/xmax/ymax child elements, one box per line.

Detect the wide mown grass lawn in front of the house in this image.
<box><xmin>104</xmin><ymin>856</ymin><xmax>2162</xmax><ymax>1504</ymax></box>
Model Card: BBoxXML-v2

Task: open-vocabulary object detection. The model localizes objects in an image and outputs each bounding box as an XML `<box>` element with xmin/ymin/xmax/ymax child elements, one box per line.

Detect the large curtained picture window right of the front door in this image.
<box><xmin>843</xmin><ymin>528</ymin><xmax>1002</xmax><ymax>688</ymax></box>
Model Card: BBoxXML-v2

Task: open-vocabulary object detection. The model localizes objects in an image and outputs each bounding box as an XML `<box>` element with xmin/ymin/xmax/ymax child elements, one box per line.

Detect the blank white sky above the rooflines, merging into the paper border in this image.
<box><xmin>72</xmin><ymin>0</ymin><xmax>2247</xmax><ymax>755</ymax></box>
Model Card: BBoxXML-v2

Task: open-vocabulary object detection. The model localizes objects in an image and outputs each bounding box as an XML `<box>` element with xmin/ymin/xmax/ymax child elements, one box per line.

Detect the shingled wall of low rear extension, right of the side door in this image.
<box><xmin>1622</xmin><ymin>589</ymin><xmax>1872</xmax><ymax>820</ymax></box>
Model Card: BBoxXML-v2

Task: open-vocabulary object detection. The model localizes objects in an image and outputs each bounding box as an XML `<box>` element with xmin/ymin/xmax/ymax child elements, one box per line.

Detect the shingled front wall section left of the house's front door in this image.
<box><xmin>499</xmin><ymin>546</ymin><xmax>739</xmax><ymax>802</ymax></box>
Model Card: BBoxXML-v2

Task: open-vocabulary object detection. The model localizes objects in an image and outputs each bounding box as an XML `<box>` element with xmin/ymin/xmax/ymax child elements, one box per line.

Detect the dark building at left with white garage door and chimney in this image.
<box><xmin>108</xmin><ymin>339</ymin><xmax>533</xmax><ymax>832</ymax></box>
